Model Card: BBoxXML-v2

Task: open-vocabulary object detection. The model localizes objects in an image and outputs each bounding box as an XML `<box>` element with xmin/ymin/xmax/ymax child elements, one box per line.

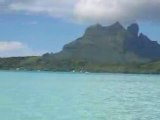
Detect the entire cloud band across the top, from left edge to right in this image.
<box><xmin>0</xmin><ymin>0</ymin><xmax>160</xmax><ymax>23</ymax></box>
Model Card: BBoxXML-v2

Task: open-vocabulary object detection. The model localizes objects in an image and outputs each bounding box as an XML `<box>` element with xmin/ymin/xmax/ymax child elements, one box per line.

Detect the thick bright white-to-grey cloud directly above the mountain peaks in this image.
<box><xmin>75</xmin><ymin>0</ymin><xmax>160</xmax><ymax>23</ymax></box>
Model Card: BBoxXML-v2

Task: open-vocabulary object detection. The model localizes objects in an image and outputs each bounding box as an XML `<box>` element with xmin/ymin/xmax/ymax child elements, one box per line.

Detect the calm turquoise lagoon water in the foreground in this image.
<box><xmin>0</xmin><ymin>71</ymin><xmax>160</xmax><ymax>120</ymax></box>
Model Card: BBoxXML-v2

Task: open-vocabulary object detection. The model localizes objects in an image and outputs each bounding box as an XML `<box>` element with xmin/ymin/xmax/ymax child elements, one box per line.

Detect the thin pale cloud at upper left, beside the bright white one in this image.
<box><xmin>9</xmin><ymin>0</ymin><xmax>77</xmax><ymax>17</ymax></box>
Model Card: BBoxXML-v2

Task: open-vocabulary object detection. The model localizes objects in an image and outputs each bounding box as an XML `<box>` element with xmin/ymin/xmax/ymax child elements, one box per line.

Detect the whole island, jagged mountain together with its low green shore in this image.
<box><xmin>0</xmin><ymin>22</ymin><xmax>160</xmax><ymax>73</ymax></box>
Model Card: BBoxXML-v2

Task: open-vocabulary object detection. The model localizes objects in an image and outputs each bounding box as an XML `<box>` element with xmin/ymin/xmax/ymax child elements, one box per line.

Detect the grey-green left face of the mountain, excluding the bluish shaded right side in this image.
<box><xmin>58</xmin><ymin>23</ymin><xmax>126</xmax><ymax>63</ymax></box>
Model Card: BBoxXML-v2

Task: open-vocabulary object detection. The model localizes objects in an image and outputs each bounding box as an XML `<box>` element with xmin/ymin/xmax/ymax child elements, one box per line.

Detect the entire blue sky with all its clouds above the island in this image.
<box><xmin>0</xmin><ymin>0</ymin><xmax>160</xmax><ymax>57</ymax></box>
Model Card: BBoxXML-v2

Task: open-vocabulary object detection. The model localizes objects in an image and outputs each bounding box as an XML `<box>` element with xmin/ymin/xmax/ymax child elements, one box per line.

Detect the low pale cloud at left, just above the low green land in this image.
<box><xmin>0</xmin><ymin>41</ymin><xmax>45</xmax><ymax>57</ymax></box>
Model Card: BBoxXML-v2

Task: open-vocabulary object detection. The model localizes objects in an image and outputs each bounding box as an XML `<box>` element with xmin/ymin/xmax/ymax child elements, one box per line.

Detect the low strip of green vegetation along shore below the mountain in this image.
<box><xmin>0</xmin><ymin>57</ymin><xmax>160</xmax><ymax>74</ymax></box>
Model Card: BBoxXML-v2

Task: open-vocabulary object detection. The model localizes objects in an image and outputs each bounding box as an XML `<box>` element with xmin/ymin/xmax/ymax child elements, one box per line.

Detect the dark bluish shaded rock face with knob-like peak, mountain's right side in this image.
<box><xmin>124</xmin><ymin>24</ymin><xmax>160</xmax><ymax>60</ymax></box>
